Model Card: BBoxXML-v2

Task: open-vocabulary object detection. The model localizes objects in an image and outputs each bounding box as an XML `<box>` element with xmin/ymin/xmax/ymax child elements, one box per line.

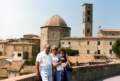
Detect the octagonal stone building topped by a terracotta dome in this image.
<box><xmin>40</xmin><ymin>15</ymin><xmax>71</xmax><ymax>50</ymax></box>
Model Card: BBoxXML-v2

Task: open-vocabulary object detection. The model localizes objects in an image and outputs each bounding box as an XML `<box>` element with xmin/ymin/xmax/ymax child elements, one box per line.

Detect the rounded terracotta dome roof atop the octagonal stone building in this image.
<box><xmin>43</xmin><ymin>15</ymin><xmax>67</xmax><ymax>27</ymax></box>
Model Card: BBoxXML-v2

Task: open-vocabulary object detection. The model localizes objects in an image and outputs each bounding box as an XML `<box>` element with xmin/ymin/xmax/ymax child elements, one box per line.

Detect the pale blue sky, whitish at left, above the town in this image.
<box><xmin>0</xmin><ymin>0</ymin><xmax>120</xmax><ymax>39</ymax></box>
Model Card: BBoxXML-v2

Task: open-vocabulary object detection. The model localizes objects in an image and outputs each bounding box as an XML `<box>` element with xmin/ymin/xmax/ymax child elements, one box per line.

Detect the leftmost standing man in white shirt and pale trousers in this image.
<box><xmin>36</xmin><ymin>45</ymin><xmax>53</xmax><ymax>81</ymax></box>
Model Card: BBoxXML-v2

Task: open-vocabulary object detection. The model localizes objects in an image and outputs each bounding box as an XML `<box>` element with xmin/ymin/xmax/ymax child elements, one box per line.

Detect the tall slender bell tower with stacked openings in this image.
<box><xmin>82</xmin><ymin>3</ymin><xmax>93</xmax><ymax>37</ymax></box>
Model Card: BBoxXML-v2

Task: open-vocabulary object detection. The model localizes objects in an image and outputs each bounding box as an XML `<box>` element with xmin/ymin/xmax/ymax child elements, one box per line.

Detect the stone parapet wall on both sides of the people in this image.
<box><xmin>0</xmin><ymin>64</ymin><xmax>120</xmax><ymax>81</ymax></box>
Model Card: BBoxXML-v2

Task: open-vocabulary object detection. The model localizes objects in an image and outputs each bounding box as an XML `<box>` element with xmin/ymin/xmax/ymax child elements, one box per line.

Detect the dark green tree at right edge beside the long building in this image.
<box><xmin>112</xmin><ymin>39</ymin><xmax>120</xmax><ymax>58</ymax></box>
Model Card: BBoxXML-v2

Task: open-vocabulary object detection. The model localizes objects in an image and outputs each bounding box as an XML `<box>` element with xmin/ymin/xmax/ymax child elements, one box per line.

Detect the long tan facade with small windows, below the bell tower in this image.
<box><xmin>61</xmin><ymin>37</ymin><xmax>118</xmax><ymax>57</ymax></box>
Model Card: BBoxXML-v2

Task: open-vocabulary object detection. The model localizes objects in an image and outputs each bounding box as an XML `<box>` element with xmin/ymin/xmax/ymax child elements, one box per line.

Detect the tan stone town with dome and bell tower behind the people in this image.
<box><xmin>0</xmin><ymin>3</ymin><xmax>120</xmax><ymax>81</ymax></box>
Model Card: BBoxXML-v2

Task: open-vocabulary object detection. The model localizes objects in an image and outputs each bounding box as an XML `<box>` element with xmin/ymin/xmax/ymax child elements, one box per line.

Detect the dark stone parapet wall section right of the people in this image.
<box><xmin>72</xmin><ymin>64</ymin><xmax>120</xmax><ymax>81</ymax></box>
